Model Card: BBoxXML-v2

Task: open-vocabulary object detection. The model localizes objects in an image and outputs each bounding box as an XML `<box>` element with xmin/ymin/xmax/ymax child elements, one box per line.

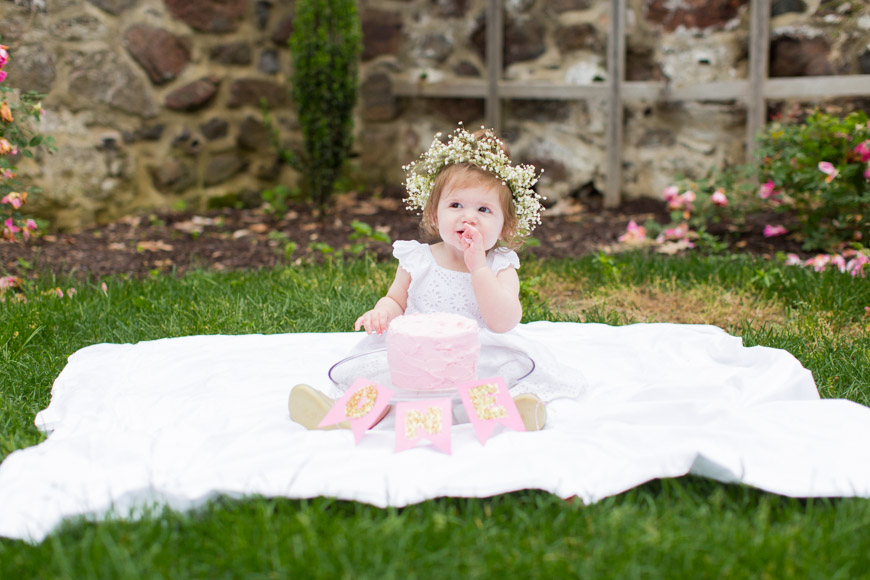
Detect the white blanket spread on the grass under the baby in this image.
<box><xmin>0</xmin><ymin>322</ymin><xmax>870</xmax><ymax>541</ymax></box>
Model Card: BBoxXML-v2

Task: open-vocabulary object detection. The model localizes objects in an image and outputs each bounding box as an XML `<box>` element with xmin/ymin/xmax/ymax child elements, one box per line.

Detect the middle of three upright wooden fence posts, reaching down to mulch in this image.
<box><xmin>604</xmin><ymin>0</ymin><xmax>625</xmax><ymax>207</ymax></box>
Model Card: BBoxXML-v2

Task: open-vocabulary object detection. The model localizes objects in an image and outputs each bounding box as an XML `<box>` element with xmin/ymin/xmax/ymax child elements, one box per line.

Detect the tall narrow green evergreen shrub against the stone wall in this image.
<box><xmin>290</xmin><ymin>0</ymin><xmax>362</xmax><ymax>209</ymax></box>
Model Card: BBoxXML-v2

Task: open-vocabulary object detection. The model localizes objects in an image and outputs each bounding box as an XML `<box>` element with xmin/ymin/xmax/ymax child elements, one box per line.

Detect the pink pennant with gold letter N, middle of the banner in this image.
<box><xmin>396</xmin><ymin>397</ymin><xmax>453</xmax><ymax>455</ymax></box>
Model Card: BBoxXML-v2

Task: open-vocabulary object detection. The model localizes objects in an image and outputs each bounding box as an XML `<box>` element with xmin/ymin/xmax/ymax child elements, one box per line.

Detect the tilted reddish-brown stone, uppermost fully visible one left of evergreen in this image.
<box><xmin>124</xmin><ymin>24</ymin><xmax>190</xmax><ymax>85</ymax></box>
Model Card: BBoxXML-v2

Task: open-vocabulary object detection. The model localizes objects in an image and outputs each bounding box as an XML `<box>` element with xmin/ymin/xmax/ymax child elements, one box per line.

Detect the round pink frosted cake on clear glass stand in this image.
<box><xmin>386</xmin><ymin>313</ymin><xmax>480</xmax><ymax>391</ymax></box>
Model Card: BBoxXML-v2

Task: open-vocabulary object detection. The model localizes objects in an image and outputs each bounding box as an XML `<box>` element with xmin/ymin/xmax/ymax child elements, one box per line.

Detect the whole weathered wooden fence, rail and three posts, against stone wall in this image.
<box><xmin>393</xmin><ymin>0</ymin><xmax>870</xmax><ymax>207</ymax></box>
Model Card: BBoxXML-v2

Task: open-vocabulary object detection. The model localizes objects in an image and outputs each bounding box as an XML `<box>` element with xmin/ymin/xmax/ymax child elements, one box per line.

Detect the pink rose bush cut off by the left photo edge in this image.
<box><xmin>0</xmin><ymin>44</ymin><xmax>55</xmax><ymax>242</ymax></box>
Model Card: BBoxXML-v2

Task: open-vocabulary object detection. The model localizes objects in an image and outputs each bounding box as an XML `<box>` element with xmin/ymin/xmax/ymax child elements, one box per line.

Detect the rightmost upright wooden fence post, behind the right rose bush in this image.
<box><xmin>746</xmin><ymin>0</ymin><xmax>770</xmax><ymax>161</ymax></box>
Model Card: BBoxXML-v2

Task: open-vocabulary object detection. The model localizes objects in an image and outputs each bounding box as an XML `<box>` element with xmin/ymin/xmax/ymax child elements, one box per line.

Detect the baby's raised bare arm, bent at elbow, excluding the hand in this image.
<box><xmin>471</xmin><ymin>266</ymin><xmax>523</xmax><ymax>332</ymax></box>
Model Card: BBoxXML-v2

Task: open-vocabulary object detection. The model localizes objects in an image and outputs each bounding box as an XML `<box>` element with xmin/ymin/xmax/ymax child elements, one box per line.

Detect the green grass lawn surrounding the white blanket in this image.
<box><xmin>0</xmin><ymin>254</ymin><xmax>870</xmax><ymax>579</ymax></box>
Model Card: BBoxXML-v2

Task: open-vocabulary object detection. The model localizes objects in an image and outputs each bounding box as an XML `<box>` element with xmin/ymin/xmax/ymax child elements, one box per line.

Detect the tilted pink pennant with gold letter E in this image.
<box><xmin>456</xmin><ymin>377</ymin><xmax>526</xmax><ymax>444</ymax></box>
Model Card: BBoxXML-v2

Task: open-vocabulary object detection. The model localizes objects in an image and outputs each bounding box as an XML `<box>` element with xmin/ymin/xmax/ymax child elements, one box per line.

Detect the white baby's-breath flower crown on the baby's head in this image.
<box><xmin>402</xmin><ymin>123</ymin><xmax>544</xmax><ymax>236</ymax></box>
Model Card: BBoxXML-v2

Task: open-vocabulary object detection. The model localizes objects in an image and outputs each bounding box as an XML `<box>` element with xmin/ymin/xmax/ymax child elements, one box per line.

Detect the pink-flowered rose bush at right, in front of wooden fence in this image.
<box><xmin>620</xmin><ymin>107</ymin><xmax>870</xmax><ymax>273</ymax></box>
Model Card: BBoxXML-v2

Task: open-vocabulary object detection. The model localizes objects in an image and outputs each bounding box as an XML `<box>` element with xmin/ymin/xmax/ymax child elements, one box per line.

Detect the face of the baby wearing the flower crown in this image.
<box><xmin>436</xmin><ymin>180</ymin><xmax>504</xmax><ymax>251</ymax></box>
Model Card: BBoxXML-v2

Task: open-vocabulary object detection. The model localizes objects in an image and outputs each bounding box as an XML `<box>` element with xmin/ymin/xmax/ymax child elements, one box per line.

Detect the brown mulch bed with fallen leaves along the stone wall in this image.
<box><xmin>0</xmin><ymin>193</ymin><xmax>812</xmax><ymax>278</ymax></box>
